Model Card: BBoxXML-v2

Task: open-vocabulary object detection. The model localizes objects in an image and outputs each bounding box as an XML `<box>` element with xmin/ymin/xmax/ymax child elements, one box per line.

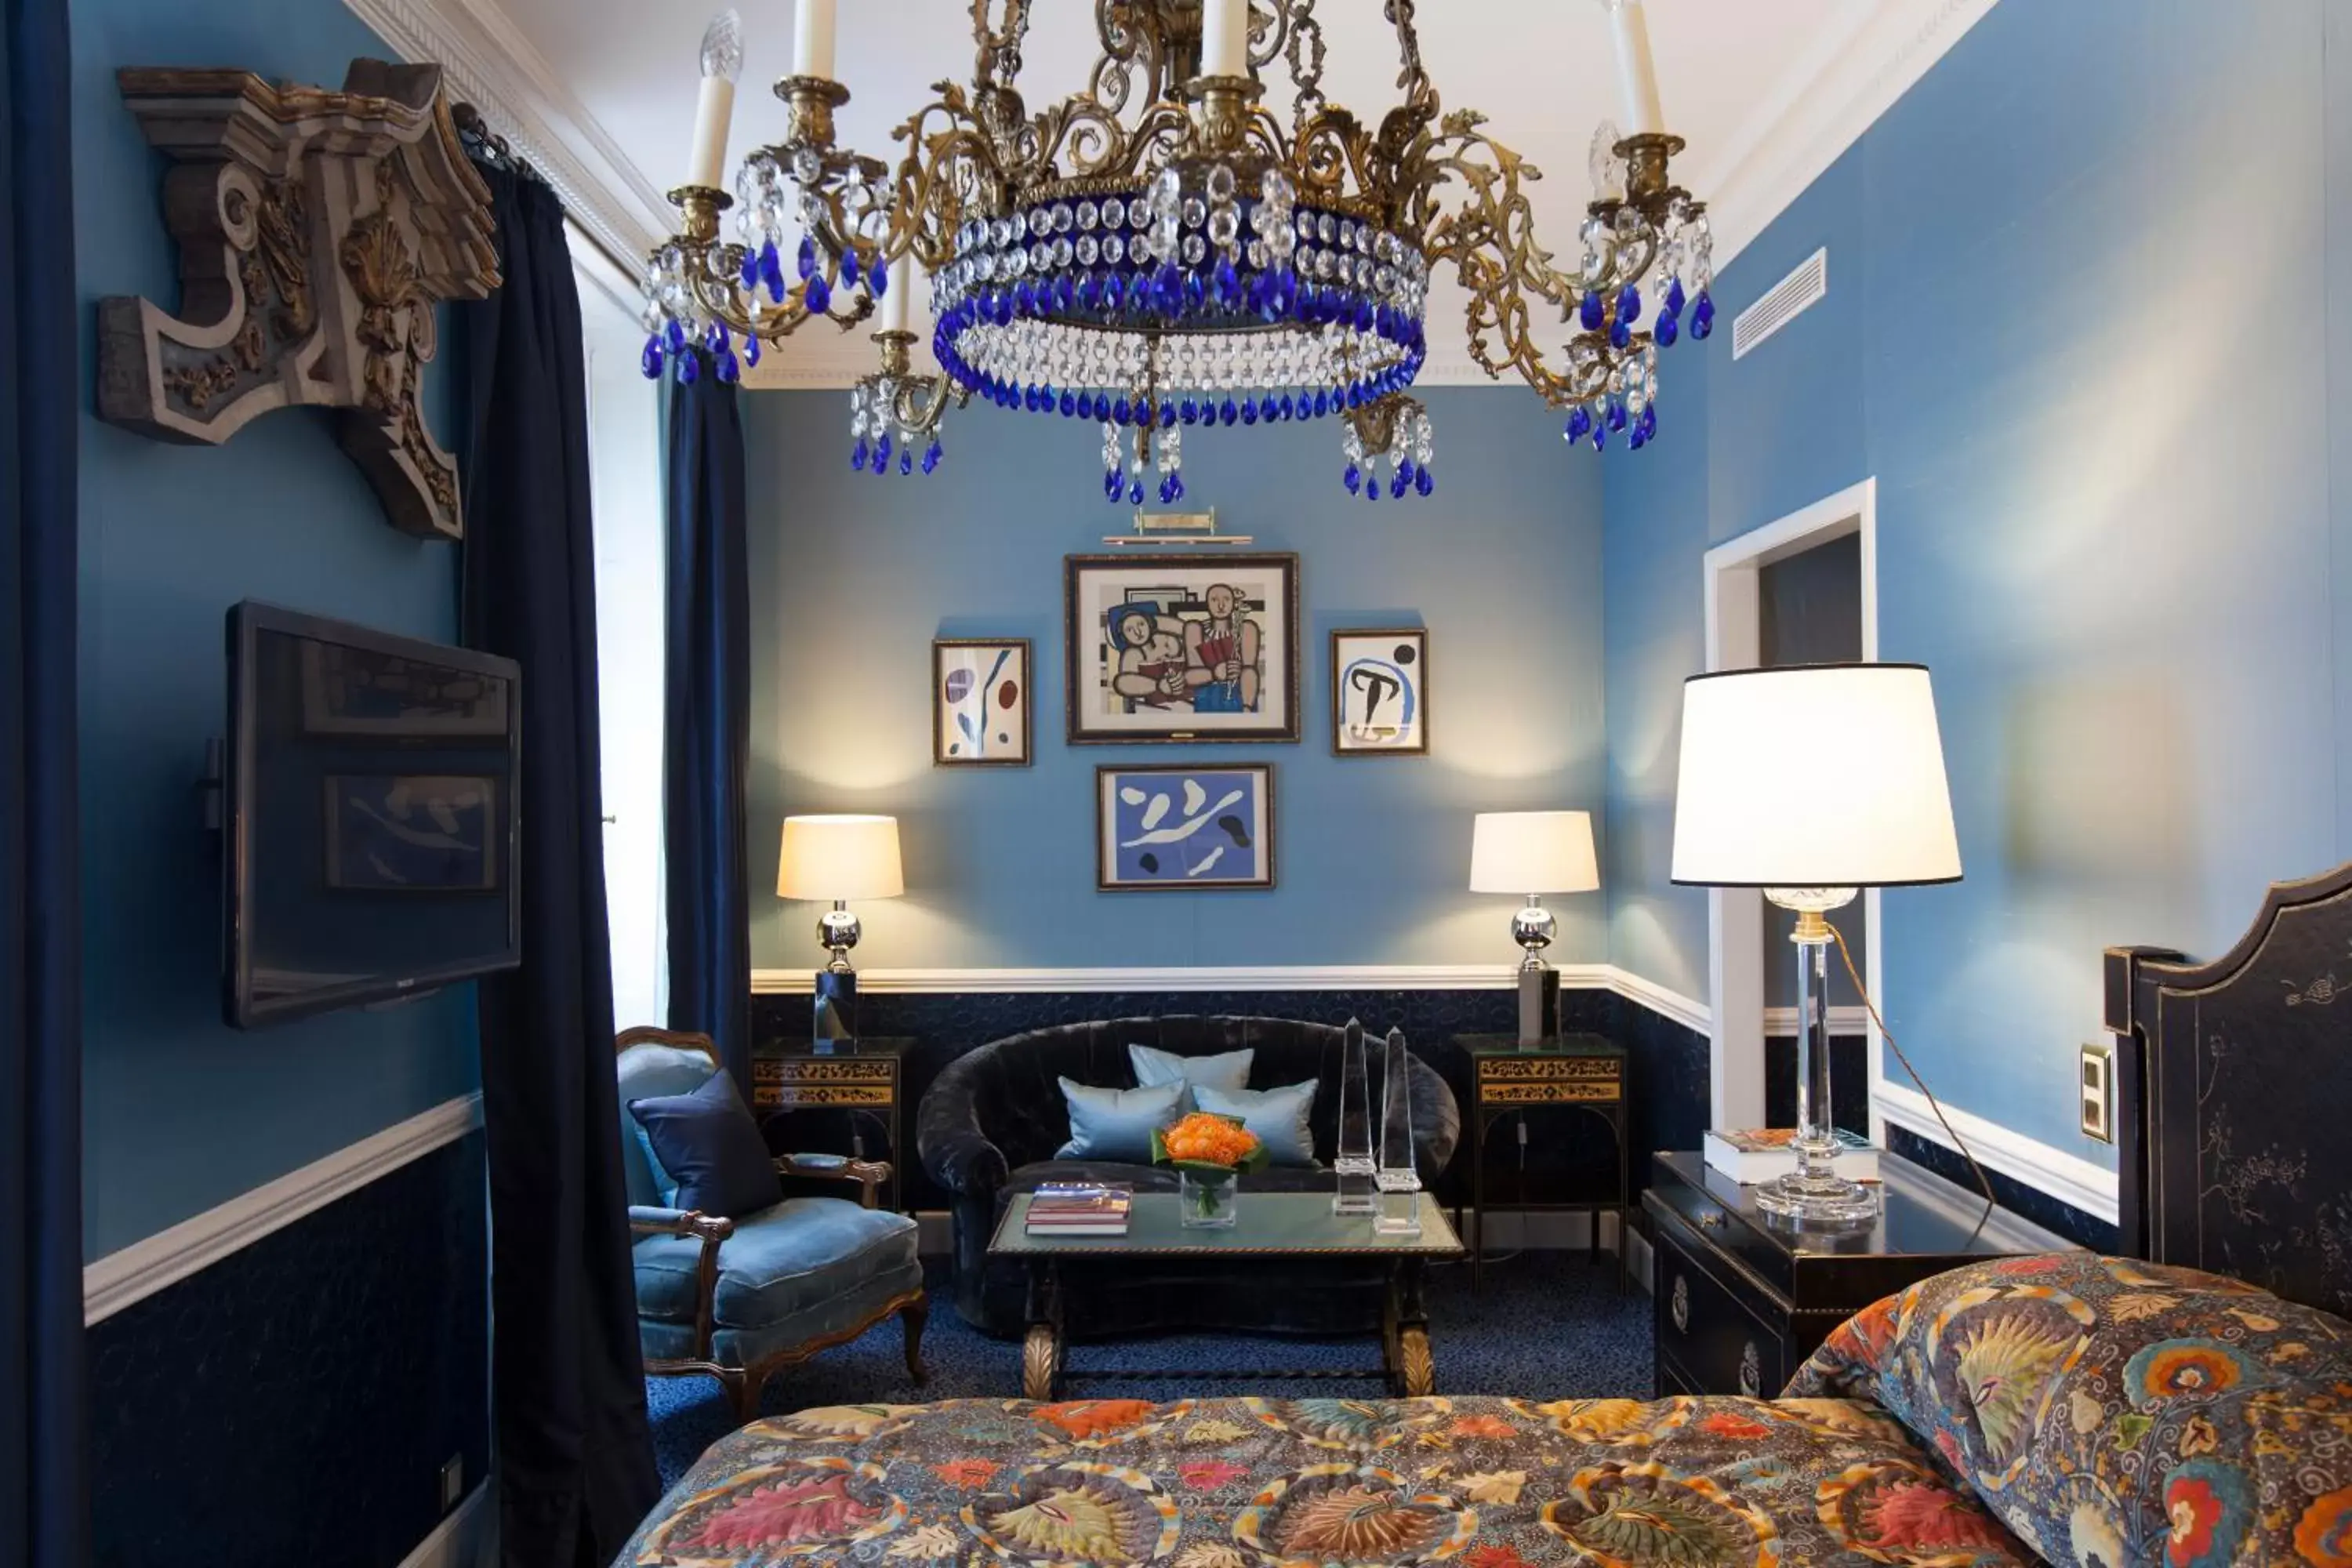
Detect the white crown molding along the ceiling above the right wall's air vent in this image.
<box><xmin>1682</xmin><ymin>0</ymin><xmax>1994</xmax><ymax>268</ymax></box>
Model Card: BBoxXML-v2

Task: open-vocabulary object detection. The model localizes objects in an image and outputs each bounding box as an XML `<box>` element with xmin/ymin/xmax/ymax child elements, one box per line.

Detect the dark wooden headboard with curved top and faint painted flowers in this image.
<box><xmin>2105</xmin><ymin>865</ymin><xmax>2352</xmax><ymax>1314</ymax></box>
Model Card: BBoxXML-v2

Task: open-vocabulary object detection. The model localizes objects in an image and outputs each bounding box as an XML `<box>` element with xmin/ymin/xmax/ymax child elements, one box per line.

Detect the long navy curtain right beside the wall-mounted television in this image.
<box><xmin>456</xmin><ymin>152</ymin><xmax>661</xmax><ymax>1568</ymax></box>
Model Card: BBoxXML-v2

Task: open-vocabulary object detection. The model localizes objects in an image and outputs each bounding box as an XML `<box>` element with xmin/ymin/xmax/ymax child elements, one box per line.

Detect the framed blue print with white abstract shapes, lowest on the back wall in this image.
<box><xmin>1094</xmin><ymin>762</ymin><xmax>1275</xmax><ymax>893</ymax></box>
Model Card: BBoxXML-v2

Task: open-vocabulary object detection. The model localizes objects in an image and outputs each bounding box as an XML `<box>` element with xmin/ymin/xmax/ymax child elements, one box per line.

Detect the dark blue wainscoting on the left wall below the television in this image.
<box><xmin>89</xmin><ymin>1131</ymin><xmax>489</xmax><ymax>1568</ymax></box>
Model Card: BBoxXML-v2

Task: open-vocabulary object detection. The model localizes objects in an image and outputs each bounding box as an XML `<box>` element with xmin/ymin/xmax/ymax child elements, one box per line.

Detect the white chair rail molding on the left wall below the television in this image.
<box><xmin>82</xmin><ymin>1093</ymin><xmax>482</xmax><ymax>1323</ymax></box>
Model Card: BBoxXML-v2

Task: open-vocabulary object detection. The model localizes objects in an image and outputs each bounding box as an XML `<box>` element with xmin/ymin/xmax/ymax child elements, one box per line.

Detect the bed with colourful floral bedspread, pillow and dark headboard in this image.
<box><xmin>616</xmin><ymin>867</ymin><xmax>2352</xmax><ymax>1568</ymax></box>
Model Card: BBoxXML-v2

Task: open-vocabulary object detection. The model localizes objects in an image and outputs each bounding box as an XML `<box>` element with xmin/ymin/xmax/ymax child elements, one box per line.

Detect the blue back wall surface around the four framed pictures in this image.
<box><xmin>746</xmin><ymin>388</ymin><xmax>1604</xmax><ymax>968</ymax></box>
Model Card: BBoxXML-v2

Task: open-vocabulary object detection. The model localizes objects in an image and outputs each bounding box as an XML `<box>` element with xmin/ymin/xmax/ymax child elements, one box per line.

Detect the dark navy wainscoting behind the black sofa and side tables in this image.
<box><xmin>753</xmin><ymin>989</ymin><xmax>1708</xmax><ymax>1208</ymax></box>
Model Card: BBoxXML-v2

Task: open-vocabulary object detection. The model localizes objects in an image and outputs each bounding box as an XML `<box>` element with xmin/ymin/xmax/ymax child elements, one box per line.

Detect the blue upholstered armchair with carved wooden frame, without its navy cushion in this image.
<box><xmin>614</xmin><ymin>1027</ymin><xmax>929</xmax><ymax>1420</ymax></box>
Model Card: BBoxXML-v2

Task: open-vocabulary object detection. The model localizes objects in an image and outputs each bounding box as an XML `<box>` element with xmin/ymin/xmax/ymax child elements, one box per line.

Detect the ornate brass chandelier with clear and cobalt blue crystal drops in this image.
<box><xmin>644</xmin><ymin>0</ymin><xmax>1715</xmax><ymax>493</ymax></box>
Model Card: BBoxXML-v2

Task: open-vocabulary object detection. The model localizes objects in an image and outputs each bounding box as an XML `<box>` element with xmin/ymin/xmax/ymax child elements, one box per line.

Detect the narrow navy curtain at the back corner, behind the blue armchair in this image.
<box><xmin>661</xmin><ymin>372</ymin><xmax>750</xmax><ymax>1098</ymax></box>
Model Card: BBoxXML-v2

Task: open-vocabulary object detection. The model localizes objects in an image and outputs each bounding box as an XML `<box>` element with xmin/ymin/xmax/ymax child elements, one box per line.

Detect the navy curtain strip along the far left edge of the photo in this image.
<box><xmin>0</xmin><ymin>0</ymin><xmax>89</xmax><ymax>1568</ymax></box>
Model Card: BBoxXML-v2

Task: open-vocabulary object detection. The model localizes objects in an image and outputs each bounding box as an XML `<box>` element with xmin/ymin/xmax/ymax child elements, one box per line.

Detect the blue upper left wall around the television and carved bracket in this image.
<box><xmin>73</xmin><ymin>0</ymin><xmax>477</xmax><ymax>1258</ymax></box>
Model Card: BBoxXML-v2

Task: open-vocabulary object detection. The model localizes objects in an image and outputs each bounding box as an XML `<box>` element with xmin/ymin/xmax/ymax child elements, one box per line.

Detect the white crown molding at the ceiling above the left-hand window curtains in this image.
<box><xmin>343</xmin><ymin>0</ymin><xmax>670</xmax><ymax>273</ymax></box>
